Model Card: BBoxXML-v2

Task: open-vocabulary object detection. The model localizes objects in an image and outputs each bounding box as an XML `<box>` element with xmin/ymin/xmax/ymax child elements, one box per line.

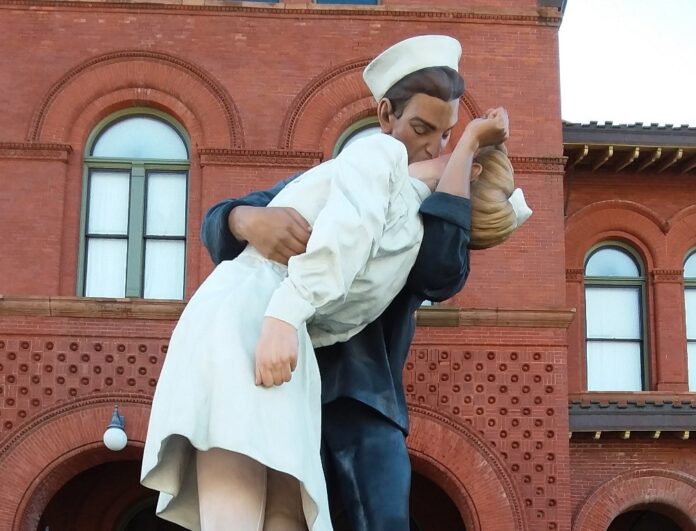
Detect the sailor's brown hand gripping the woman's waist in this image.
<box><xmin>228</xmin><ymin>206</ymin><xmax>311</xmax><ymax>265</ymax></box>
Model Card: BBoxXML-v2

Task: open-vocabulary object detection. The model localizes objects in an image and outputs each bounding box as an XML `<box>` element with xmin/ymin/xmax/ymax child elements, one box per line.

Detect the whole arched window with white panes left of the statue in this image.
<box><xmin>78</xmin><ymin>110</ymin><xmax>189</xmax><ymax>299</ymax></box>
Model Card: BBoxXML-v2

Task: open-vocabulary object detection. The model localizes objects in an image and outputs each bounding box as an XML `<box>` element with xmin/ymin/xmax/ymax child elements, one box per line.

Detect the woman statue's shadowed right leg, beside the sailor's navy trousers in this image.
<box><xmin>263</xmin><ymin>468</ymin><xmax>307</xmax><ymax>531</ymax></box>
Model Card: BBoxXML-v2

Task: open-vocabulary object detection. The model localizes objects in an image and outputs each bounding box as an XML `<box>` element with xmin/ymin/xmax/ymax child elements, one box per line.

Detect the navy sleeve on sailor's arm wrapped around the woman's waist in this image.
<box><xmin>201</xmin><ymin>173</ymin><xmax>300</xmax><ymax>265</ymax></box>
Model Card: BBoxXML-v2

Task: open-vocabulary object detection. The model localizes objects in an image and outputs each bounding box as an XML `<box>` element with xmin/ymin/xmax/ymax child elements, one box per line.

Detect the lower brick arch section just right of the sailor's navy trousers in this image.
<box><xmin>407</xmin><ymin>405</ymin><xmax>528</xmax><ymax>531</ymax></box>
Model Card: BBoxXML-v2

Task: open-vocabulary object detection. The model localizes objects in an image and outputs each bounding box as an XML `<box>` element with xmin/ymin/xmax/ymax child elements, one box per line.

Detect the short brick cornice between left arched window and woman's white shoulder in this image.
<box><xmin>198</xmin><ymin>148</ymin><xmax>324</xmax><ymax>168</ymax></box>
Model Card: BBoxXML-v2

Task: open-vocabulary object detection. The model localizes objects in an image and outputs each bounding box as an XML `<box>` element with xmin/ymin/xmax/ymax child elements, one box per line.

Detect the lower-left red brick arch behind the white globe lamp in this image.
<box><xmin>0</xmin><ymin>394</ymin><xmax>151</xmax><ymax>531</ymax></box>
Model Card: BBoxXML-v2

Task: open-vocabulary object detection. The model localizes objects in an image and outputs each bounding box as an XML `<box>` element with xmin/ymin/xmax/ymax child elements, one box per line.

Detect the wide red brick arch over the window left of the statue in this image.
<box><xmin>27</xmin><ymin>50</ymin><xmax>244</xmax><ymax>148</ymax></box>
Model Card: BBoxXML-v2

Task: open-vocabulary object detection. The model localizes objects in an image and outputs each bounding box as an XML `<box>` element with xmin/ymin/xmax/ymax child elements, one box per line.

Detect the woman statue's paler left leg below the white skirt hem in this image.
<box><xmin>196</xmin><ymin>448</ymin><xmax>266</xmax><ymax>531</ymax></box>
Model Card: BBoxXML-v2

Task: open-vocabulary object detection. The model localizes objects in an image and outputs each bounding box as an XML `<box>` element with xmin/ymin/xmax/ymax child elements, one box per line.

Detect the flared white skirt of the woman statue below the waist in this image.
<box><xmin>142</xmin><ymin>253</ymin><xmax>331</xmax><ymax>531</ymax></box>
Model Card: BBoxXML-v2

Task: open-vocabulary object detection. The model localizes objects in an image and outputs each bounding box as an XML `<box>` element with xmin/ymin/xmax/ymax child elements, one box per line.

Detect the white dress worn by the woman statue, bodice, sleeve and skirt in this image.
<box><xmin>141</xmin><ymin>134</ymin><xmax>430</xmax><ymax>531</ymax></box>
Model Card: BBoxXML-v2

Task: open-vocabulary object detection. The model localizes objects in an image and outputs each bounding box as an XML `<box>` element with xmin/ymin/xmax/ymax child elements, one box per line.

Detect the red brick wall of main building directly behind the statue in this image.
<box><xmin>0</xmin><ymin>0</ymin><xmax>570</xmax><ymax>531</ymax></box>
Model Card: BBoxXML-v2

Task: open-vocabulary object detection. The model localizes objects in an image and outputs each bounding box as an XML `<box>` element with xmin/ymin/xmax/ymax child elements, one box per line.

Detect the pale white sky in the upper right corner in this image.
<box><xmin>559</xmin><ymin>0</ymin><xmax>696</xmax><ymax>126</ymax></box>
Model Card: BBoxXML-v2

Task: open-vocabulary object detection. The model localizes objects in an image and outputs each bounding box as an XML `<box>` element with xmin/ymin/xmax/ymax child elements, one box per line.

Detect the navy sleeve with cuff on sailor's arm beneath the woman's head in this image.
<box><xmin>406</xmin><ymin>192</ymin><xmax>471</xmax><ymax>302</ymax></box>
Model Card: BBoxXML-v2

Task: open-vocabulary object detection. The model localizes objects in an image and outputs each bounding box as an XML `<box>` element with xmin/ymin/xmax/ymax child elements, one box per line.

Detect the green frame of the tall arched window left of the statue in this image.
<box><xmin>77</xmin><ymin>108</ymin><xmax>191</xmax><ymax>300</ymax></box>
